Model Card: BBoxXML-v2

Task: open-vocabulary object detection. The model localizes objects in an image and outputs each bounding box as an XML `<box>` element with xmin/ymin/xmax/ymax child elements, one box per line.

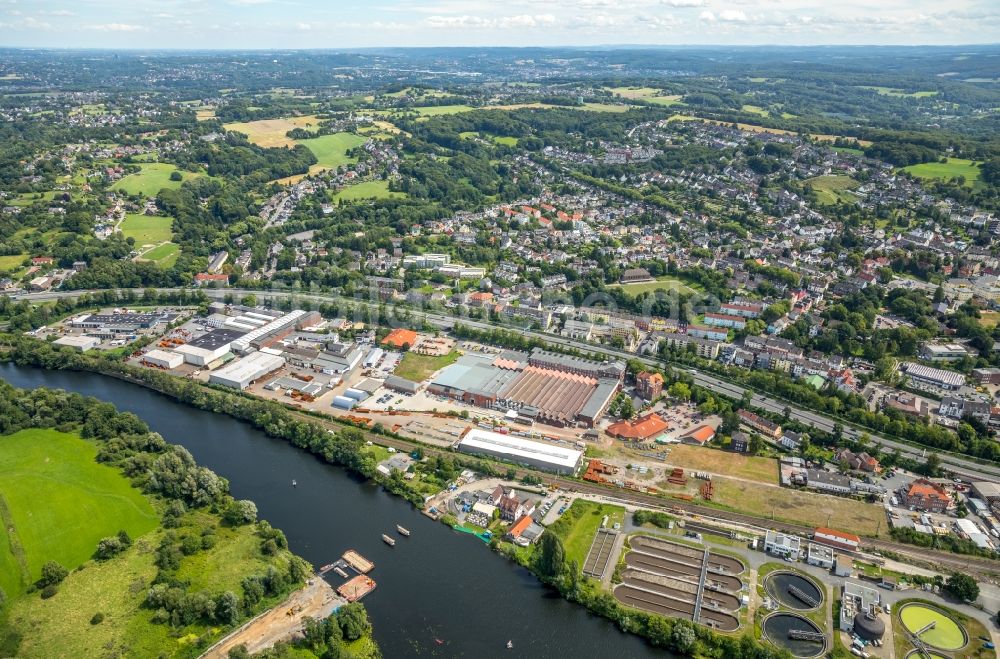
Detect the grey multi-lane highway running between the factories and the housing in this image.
<box><xmin>13</xmin><ymin>288</ymin><xmax>1000</xmax><ymax>483</ymax></box>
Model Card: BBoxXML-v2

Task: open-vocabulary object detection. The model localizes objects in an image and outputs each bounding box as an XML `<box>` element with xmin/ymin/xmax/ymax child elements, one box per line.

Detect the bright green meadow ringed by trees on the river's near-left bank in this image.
<box><xmin>0</xmin><ymin>429</ymin><xmax>157</xmax><ymax>596</ymax></box>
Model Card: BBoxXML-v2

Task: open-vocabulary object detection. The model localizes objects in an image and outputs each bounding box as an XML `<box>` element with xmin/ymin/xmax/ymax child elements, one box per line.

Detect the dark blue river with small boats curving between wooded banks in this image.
<box><xmin>0</xmin><ymin>364</ymin><xmax>673</xmax><ymax>659</ymax></box>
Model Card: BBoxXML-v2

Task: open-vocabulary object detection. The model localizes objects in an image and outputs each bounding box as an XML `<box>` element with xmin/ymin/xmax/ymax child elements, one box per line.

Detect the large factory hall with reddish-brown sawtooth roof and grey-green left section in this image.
<box><xmin>427</xmin><ymin>348</ymin><xmax>625</xmax><ymax>427</ymax></box>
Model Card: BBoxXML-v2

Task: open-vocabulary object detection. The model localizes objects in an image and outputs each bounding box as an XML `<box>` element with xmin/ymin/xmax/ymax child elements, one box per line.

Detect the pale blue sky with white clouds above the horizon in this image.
<box><xmin>0</xmin><ymin>0</ymin><xmax>1000</xmax><ymax>49</ymax></box>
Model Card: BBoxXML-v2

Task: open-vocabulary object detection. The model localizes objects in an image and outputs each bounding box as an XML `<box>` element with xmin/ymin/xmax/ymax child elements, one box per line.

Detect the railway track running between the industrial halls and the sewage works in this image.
<box><xmin>290</xmin><ymin>409</ymin><xmax>1000</xmax><ymax>577</ymax></box>
